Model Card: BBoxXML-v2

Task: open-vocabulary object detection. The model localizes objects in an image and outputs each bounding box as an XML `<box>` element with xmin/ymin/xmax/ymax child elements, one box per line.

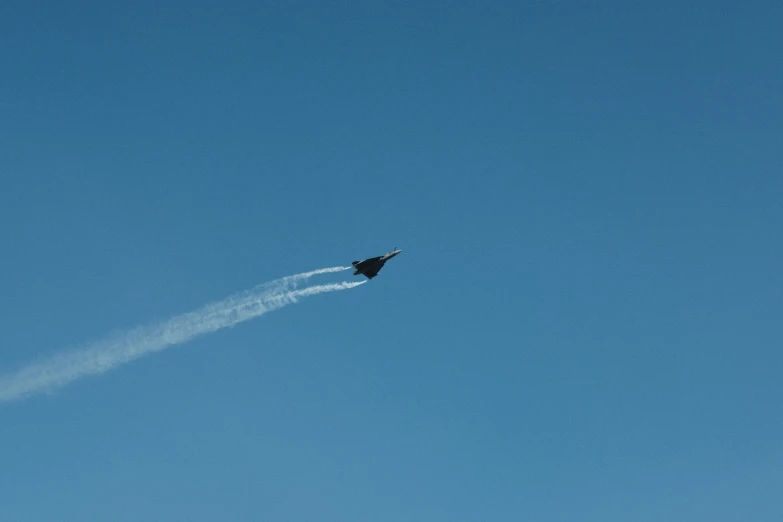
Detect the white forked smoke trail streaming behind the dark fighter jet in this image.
<box><xmin>0</xmin><ymin>267</ymin><xmax>366</xmax><ymax>401</ymax></box>
